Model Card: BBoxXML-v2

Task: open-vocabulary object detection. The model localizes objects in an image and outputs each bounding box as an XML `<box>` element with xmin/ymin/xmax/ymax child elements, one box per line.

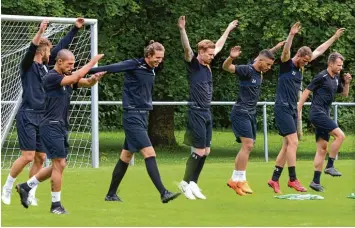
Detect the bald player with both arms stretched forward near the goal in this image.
<box><xmin>16</xmin><ymin>49</ymin><xmax>103</xmax><ymax>214</ymax></box>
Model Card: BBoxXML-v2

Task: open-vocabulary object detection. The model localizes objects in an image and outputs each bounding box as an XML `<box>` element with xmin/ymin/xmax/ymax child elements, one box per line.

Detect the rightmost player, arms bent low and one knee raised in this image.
<box><xmin>298</xmin><ymin>52</ymin><xmax>352</xmax><ymax>192</ymax></box>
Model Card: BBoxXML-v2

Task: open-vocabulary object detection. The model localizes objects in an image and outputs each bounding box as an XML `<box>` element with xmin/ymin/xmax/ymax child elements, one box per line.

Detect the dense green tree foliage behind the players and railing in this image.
<box><xmin>1</xmin><ymin>0</ymin><xmax>355</xmax><ymax>144</ymax></box>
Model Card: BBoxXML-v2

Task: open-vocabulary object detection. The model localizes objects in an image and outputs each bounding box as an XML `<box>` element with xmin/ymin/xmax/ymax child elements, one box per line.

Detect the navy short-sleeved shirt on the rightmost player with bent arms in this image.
<box><xmin>307</xmin><ymin>70</ymin><xmax>344</xmax><ymax>114</ymax></box>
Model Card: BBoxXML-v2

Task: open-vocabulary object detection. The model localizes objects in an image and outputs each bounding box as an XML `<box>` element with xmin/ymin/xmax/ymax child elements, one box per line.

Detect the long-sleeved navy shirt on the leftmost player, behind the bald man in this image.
<box><xmin>19</xmin><ymin>26</ymin><xmax>78</xmax><ymax>112</ymax></box>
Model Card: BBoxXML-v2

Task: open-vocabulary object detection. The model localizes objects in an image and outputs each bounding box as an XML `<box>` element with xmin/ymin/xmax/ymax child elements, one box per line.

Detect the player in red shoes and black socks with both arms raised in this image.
<box><xmin>268</xmin><ymin>22</ymin><xmax>344</xmax><ymax>193</ymax></box>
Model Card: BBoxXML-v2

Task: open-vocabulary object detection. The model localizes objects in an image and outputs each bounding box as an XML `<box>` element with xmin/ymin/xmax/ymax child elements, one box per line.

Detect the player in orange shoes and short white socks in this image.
<box><xmin>223</xmin><ymin>46</ymin><xmax>275</xmax><ymax>196</ymax></box>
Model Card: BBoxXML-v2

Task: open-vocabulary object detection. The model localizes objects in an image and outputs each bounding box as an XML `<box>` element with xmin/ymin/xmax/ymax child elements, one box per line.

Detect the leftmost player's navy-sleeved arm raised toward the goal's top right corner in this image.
<box><xmin>48</xmin><ymin>18</ymin><xmax>85</xmax><ymax>65</ymax></box>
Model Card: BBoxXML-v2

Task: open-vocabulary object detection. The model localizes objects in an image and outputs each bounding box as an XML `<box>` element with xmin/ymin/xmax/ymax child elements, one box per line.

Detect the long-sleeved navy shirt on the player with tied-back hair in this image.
<box><xmin>89</xmin><ymin>58</ymin><xmax>155</xmax><ymax>110</ymax></box>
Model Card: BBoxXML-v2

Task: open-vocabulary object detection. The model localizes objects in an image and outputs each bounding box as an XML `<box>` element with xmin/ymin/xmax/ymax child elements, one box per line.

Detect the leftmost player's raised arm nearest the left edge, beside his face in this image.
<box><xmin>20</xmin><ymin>20</ymin><xmax>48</xmax><ymax>72</ymax></box>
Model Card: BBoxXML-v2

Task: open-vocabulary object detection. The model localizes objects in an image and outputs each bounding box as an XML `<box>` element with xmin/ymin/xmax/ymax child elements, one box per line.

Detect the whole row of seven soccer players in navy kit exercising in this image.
<box><xmin>2</xmin><ymin>16</ymin><xmax>352</xmax><ymax>214</ymax></box>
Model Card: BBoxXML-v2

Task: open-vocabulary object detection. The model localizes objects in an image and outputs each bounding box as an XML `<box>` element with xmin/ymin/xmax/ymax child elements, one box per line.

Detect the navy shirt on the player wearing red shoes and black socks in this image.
<box><xmin>275</xmin><ymin>59</ymin><xmax>302</xmax><ymax>109</ymax></box>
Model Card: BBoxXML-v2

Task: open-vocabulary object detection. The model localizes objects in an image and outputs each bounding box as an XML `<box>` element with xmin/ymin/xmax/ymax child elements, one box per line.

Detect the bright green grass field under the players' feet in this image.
<box><xmin>1</xmin><ymin>132</ymin><xmax>355</xmax><ymax>226</ymax></box>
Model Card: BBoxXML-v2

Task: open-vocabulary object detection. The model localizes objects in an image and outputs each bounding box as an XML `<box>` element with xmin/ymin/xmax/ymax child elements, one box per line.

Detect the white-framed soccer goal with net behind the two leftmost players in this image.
<box><xmin>0</xmin><ymin>15</ymin><xmax>99</xmax><ymax>169</ymax></box>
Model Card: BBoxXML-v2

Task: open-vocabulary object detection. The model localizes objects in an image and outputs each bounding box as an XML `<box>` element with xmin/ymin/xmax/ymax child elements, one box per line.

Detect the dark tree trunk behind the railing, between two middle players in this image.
<box><xmin>148</xmin><ymin>105</ymin><xmax>177</xmax><ymax>146</ymax></box>
